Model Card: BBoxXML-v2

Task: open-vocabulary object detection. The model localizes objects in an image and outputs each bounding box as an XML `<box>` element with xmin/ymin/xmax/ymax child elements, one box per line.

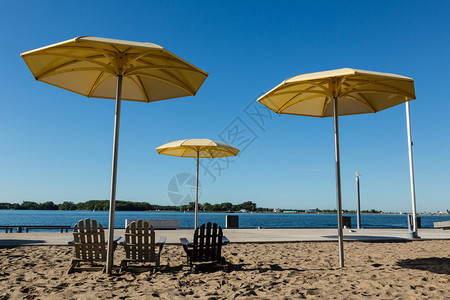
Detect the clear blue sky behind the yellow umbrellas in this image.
<box><xmin>0</xmin><ymin>0</ymin><xmax>450</xmax><ymax>212</ymax></box>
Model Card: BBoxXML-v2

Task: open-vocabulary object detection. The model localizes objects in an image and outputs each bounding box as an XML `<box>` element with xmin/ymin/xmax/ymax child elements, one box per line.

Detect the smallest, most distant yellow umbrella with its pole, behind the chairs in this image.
<box><xmin>156</xmin><ymin>139</ymin><xmax>239</xmax><ymax>228</ymax></box>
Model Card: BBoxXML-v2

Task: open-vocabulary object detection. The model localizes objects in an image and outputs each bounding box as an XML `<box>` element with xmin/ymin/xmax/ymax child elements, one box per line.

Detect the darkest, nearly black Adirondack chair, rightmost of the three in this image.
<box><xmin>180</xmin><ymin>222</ymin><xmax>230</xmax><ymax>272</ymax></box>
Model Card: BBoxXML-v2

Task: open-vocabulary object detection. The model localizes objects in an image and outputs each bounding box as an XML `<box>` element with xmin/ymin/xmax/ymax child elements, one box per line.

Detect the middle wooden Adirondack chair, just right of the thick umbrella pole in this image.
<box><xmin>119</xmin><ymin>220</ymin><xmax>166</xmax><ymax>271</ymax></box>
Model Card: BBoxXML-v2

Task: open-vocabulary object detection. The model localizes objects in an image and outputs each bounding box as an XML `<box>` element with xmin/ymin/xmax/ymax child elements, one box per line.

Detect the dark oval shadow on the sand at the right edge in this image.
<box><xmin>396</xmin><ymin>257</ymin><xmax>450</xmax><ymax>275</ymax></box>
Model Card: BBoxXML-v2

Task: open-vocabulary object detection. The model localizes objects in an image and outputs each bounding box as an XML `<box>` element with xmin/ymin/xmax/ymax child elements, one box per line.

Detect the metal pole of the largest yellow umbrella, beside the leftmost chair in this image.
<box><xmin>106</xmin><ymin>75</ymin><xmax>122</xmax><ymax>274</ymax></box>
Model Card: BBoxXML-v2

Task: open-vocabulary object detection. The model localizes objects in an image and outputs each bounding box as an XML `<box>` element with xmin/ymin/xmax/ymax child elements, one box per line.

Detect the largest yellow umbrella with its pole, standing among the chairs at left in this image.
<box><xmin>21</xmin><ymin>36</ymin><xmax>208</xmax><ymax>273</ymax></box>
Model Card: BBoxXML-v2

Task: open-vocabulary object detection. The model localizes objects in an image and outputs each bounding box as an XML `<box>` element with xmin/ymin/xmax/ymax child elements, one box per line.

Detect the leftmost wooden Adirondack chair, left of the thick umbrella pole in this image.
<box><xmin>67</xmin><ymin>219</ymin><xmax>118</xmax><ymax>273</ymax></box>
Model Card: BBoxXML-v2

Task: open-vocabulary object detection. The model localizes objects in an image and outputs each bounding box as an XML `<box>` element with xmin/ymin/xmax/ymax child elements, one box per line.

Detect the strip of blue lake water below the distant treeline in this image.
<box><xmin>0</xmin><ymin>210</ymin><xmax>450</xmax><ymax>228</ymax></box>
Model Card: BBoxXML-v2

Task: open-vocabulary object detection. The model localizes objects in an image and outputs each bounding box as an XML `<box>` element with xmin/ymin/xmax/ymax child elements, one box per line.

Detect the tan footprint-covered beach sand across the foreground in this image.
<box><xmin>0</xmin><ymin>240</ymin><xmax>450</xmax><ymax>299</ymax></box>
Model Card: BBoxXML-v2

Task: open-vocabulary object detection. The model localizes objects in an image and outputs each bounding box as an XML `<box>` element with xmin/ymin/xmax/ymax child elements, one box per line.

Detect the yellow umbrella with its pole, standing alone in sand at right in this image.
<box><xmin>257</xmin><ymin>68</ymin><xmax>416</xmax><ymax>267</ymax></box>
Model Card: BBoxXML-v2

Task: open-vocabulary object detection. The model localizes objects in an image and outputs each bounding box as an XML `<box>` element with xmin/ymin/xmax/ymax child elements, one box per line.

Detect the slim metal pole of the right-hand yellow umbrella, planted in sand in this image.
<box><xmin>333</xmin><ymin>97</ymin><xmax>344</xmax><ymax>268</ymax></box>
